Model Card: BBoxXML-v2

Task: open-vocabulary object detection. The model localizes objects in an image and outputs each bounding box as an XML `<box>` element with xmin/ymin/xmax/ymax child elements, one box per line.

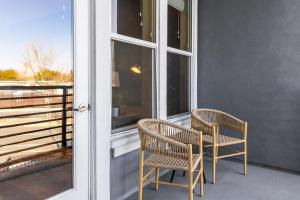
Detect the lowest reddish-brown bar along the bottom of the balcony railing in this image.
<box><xmin>0</xmin><ymin>148</ymin><xmax>68</xmax><ymax>170</ymax></box>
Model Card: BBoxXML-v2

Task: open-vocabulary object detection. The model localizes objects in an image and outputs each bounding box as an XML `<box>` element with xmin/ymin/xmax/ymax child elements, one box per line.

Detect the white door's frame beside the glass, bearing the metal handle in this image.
<box><xmin>49</xmin><ymin>0</ymin><xmax>90</xmax><ymax>200</ymax></box>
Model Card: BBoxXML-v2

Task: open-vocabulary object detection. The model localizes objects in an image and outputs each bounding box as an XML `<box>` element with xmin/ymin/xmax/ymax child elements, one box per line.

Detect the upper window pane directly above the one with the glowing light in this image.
<box><xmin>112</xmin><ymin>0</ymin><xmax>156</xmax><ymax>42</ymax></box>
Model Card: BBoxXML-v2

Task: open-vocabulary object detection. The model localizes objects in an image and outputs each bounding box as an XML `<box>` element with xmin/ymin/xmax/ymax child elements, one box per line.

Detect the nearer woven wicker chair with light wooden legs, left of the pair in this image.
<box><xmin>137</xmin><ymin>119</ymin><xmax>203</xmax><ymax>200</ymax></box>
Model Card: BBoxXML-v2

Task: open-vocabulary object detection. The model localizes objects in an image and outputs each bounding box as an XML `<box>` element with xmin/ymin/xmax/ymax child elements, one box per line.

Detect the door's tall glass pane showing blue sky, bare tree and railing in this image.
<box><xmin>0</xmin><ymin>0</ymin><xmax>73</xmax><ymax>200</ymax></box>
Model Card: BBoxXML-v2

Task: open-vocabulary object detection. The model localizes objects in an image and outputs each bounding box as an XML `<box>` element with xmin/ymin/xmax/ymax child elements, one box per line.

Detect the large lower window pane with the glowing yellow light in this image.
<box><xmin>112</xmin><ymin>41</ymin><xmax>154</xmax><ymax>129</ymax></box>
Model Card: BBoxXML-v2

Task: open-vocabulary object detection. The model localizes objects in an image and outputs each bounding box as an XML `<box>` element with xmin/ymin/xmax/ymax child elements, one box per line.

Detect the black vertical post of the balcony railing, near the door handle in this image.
<box><xmin>61</xmin><ymin>87</ymin><xmax>68</xmax><ymax>148</ymax></box>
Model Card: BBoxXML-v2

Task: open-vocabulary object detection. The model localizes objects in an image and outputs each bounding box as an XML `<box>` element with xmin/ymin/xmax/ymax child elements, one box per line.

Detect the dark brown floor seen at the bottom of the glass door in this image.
<box><xmin>0</xmin><ymin>164</ymin><xmax>72</xmax><ymax>200</ymax></box>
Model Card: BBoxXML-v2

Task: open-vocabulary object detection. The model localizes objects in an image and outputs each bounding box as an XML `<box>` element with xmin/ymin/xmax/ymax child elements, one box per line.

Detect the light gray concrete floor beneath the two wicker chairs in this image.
<box><xmin>127</xmin><ymin>160</ymin><xmax>300</xmax><ymax>200</ymax></box>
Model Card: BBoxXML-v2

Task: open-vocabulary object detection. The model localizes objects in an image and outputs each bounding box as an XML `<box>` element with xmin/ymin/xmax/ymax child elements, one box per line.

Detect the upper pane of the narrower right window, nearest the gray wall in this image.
<box><xmin>168</xmin><ymin>0</ymin><xmax>192</xmax><ymax>51</ymax></box>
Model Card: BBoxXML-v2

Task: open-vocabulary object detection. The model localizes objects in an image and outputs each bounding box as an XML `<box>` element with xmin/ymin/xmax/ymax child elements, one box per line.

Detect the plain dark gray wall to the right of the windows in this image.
<box><xmin>198</xmin><ymin>0</ymin><xmax>300</xmax><ymax>171</ymax></box>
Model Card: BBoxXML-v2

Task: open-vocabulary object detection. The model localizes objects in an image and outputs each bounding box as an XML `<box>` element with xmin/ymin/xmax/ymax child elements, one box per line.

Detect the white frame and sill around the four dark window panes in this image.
<box><xmin>106</xmin><ymin>0</ymin><xmax>198</xmax><ymax>150</ymax></box>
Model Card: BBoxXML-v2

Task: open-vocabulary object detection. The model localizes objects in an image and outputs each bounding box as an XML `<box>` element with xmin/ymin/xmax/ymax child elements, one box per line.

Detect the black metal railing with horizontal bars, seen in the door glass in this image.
<box><xmin>0</xmin><ymin>85</ymin><xmax>73</xmax><ymax>172</ymax></box>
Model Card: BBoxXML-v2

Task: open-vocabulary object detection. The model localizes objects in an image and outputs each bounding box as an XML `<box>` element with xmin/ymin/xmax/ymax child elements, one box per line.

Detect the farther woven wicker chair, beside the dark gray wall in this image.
<box><xmin>192</xmin><ymin>109</ymin><xmax>247</xmax><ymax>183</ymax></box>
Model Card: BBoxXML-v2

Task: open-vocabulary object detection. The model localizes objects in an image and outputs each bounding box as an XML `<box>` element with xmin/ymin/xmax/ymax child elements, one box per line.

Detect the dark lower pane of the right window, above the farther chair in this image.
<box><xmin>167</xmin><ymin>53</ymin><xmax>190</xmax><ymax>116</ymax></box>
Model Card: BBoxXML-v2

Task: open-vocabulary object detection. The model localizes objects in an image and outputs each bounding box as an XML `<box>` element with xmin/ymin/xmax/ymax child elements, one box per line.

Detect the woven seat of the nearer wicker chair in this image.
<box><xmin>145</xmin><ymin>154</ymin><xmax>201</xmax><ymax>171</ymax></box>
